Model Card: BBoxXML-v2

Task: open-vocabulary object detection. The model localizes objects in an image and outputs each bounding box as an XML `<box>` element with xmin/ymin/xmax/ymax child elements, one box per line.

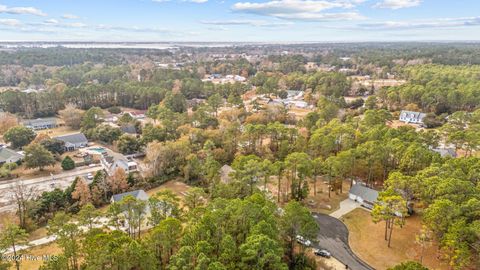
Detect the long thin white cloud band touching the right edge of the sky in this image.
<box><xmin>358</xmin><ymin>17</ymin><xmax>480</xmax><ymax>30</ymax></box>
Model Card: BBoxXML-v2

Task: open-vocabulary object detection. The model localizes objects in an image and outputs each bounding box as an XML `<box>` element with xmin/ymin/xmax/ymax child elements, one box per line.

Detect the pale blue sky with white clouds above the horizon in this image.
<box><xmin>0</xmin><ymin>0</ymin><xmax>480</xmax><ymax>42</ymax></box>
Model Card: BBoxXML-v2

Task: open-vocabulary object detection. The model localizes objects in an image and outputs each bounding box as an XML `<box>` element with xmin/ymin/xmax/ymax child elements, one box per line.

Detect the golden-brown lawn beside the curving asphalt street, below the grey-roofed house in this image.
<box><xmin>342</xmin><ymin>209</ymin><xmax>448</xmax><ymax>269</ymax></box>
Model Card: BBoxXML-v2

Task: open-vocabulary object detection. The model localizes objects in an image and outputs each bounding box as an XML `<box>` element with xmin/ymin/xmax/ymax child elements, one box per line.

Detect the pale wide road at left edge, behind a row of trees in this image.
<box><xmin>0</xmin><ymin>166</ymin><xmax>103</xmax><ymax>213</ymax></box>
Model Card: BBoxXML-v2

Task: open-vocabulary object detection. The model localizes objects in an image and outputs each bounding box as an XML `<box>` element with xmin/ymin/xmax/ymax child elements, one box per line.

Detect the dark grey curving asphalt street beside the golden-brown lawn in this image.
<box><xmin>313</xmin><ymin>214</ymin><xmax>373</xmax><ymax>270</ymax></box>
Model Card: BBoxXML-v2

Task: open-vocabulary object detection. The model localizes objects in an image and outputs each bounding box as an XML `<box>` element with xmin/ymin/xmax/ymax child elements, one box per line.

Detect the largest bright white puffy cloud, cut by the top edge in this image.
<box><xmin>232</xmin><ymin>0</ymin><xmax>364</xmax><ymax>21</ymax></box>
